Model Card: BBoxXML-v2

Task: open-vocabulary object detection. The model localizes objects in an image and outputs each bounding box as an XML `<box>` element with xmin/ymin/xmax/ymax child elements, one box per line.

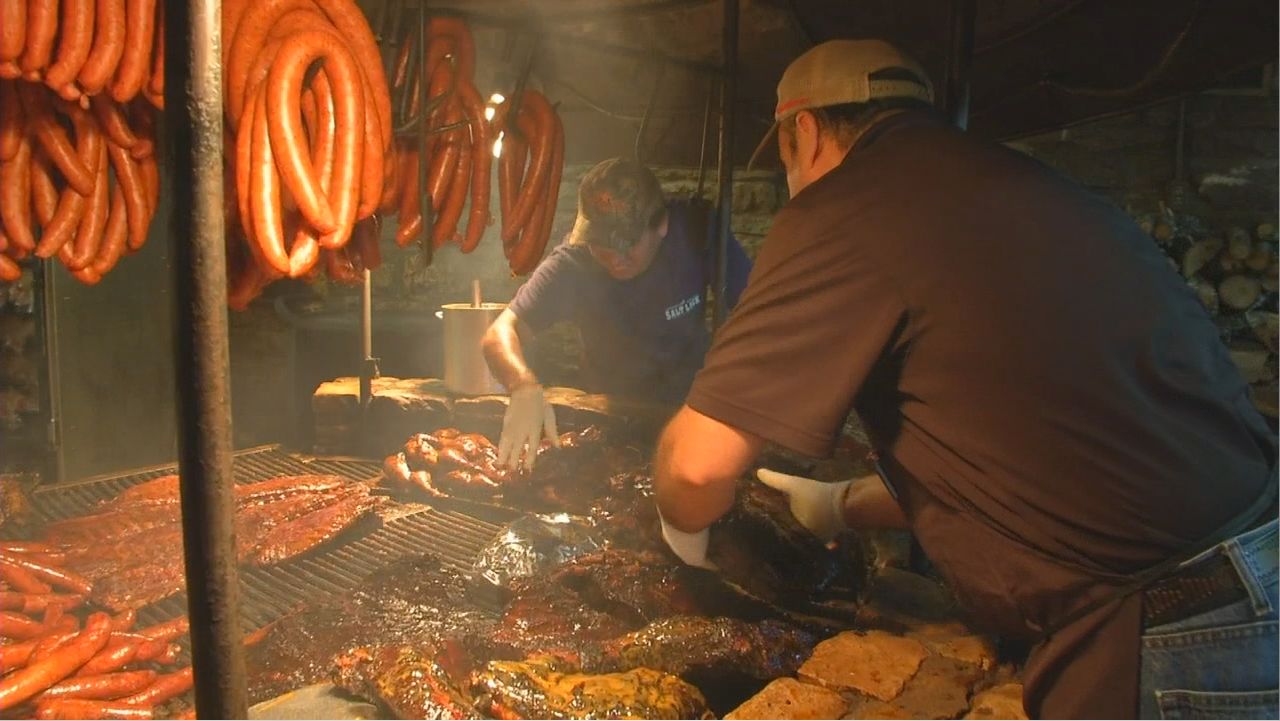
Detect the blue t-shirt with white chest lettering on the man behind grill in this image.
<box><xmin>509</xmin><ymin>202</ymin><xmax>751</xmax><ymax>401</ymax></box>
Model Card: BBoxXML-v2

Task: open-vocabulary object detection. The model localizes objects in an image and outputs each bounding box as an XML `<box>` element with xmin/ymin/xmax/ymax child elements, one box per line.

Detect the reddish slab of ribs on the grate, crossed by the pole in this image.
<box><xmin>44</xmin><ymin>475</ymin><xmax>381</xmax><ymax>611</ymax></box>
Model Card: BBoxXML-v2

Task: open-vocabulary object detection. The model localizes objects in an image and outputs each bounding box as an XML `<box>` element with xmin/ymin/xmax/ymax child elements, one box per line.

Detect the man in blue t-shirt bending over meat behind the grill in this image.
<box><xmin>484</xmin><ymin>158</ymin><xmax>751</xmax><ymax>466</ymax></box>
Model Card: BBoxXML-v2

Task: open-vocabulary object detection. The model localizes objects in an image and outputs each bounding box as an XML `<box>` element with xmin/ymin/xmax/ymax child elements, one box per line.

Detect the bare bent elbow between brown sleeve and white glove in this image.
<box><xmin>654</xmin><ymin>406</ymin><xmax>763</xmax><ymax>533</ymax></box>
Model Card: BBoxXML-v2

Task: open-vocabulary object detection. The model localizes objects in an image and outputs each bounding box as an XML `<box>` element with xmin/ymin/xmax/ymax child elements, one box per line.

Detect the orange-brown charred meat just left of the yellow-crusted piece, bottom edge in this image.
<box><xmin>334</xmin><ymin>645</ymin><xmax>479</xmax><ymax>718</ymax></box>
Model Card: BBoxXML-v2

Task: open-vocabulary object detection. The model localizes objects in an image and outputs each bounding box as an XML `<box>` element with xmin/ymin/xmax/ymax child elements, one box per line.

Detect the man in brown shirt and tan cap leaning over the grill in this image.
<box><xmin>655</xmin><ymin>41</ymin><xmax>1276</xmax><ymax>717</ymax></box>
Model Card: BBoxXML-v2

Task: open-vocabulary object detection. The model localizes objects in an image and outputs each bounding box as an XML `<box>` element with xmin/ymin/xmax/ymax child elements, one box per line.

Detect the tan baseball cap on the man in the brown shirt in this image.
<box><xmin>748</xmin><ymin>40</ymin><xmax>933</xmax><ymax>168</ymax></box>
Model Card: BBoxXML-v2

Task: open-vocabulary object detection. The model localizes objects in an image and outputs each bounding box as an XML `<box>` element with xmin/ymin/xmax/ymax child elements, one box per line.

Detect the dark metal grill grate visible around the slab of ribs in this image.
<box><xmin>26</xmin><ymin>446</ymin><xmax>502</xmax><ymax>645</ymax></box>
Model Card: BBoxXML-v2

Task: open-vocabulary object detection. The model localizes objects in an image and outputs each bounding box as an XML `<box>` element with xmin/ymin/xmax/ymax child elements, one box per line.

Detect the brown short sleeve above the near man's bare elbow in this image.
<box><xmin>686</xmin><ymin>204</ymin><xmax>906</xmax><ymax>456</ymax></box>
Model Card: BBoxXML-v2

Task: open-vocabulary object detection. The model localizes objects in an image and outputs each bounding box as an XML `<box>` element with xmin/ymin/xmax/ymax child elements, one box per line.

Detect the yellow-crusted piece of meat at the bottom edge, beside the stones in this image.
<box><xmin>471</xmin><ymin>657</ymin><xmax>709</xmax><ymax>718</ymax></box>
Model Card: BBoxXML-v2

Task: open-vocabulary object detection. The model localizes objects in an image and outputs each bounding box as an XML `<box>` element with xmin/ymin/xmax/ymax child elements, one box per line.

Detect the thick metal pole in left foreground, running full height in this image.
<box><xmin>164</xmin><ymin>0</ymin><xmax>248</xmax><ymax>718</ymax></box>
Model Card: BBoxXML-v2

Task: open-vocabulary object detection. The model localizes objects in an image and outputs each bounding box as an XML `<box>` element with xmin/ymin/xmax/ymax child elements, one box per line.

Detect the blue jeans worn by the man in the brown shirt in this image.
<box><xmin>1139</xmin><ymin>521</ymin><xmax>1280</xmax><ymax>718</ymax></box>
